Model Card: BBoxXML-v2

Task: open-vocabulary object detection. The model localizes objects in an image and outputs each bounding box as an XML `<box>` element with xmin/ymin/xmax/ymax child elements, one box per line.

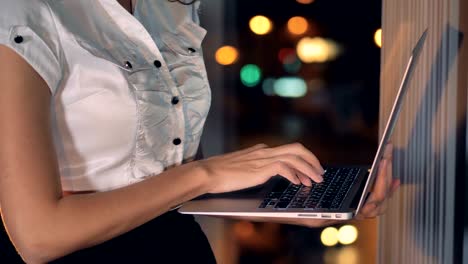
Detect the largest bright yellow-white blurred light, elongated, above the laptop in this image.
<box><xmin>296</xmin><ymin>37</ymin><xmax>340</xmax><ymax>63</ymax></box>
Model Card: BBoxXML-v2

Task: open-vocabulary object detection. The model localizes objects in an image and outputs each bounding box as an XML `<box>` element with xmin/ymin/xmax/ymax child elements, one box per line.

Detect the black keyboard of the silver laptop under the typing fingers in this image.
<box><xmin>259</xmin><ymin>168</ymin><xmax>360</xmax><ymax>209</ymax></box>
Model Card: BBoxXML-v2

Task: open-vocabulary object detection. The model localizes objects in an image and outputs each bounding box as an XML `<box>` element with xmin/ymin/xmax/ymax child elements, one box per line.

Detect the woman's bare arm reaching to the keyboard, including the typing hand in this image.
<box><xmin>0</xmin><ymin>45</ymin><xmax>323</xmax><ymax>263</ymax></box>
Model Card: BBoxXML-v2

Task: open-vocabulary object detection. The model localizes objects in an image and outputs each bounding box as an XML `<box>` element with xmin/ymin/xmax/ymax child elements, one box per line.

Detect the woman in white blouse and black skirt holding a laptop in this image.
<box><xmin>0</xmin><ymin>0</ymin><xmax>398</xmax><ymax>263</ymax></box>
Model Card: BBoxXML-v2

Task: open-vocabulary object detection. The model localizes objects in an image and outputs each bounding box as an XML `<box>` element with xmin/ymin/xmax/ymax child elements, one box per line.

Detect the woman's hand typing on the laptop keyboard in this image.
<box><xmin>198</xmin><ymin>143</ymin><xmax>324</xmax><ymax>193</ymax></box>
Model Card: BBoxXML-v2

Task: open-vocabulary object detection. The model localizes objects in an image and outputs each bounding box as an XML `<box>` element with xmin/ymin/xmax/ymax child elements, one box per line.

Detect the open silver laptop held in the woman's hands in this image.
<box><xmin>179</xmin><ymin>30</ymin><xmax>427</xmax><ymax>220</ymax></box>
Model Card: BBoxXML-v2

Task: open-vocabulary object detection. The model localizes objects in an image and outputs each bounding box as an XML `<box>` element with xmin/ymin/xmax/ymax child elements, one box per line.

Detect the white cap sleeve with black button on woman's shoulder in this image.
<box><xmin>0</xmin><ymin>0</ymin><xmax>63</xmax><ymax>93</ymax></box>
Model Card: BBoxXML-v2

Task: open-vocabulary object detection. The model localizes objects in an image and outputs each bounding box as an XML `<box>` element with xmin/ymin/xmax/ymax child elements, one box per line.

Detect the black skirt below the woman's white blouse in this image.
<box><xmin>0</xmin><ymin>211</ymin><xmax>216</xmax><ymax>264</ymax></box>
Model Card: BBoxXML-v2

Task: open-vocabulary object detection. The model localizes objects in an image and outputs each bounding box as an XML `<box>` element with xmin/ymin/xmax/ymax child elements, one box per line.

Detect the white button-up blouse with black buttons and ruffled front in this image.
<box><xmin>0</xmin><ymin>0</ymin><xmax>211</xmax><ymax>191</ymax></box>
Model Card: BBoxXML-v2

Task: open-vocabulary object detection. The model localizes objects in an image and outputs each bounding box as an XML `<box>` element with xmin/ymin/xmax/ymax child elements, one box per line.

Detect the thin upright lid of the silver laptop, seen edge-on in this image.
<box><xmin>356</xmin><ymin>29</ymin><xmax>427</xmax><ymax>214</ymax></box>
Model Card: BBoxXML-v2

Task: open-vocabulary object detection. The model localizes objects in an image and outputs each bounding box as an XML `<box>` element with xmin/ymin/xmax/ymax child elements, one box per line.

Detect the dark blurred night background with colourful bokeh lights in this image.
<box><xmin>199</xmin><ymin>0</ymin><xmax>382</xmax><ymax>264</ymax></box>
